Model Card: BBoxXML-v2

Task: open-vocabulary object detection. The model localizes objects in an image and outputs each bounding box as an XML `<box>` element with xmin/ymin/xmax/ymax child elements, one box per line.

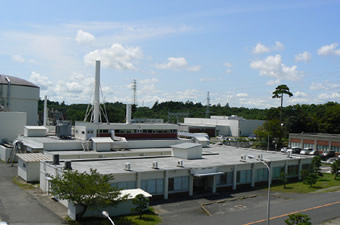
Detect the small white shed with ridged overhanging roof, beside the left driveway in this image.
<box><xmin>17</xmin><ymin>153</ymin><xmax>50</xmax><ymax>182</ymax></box>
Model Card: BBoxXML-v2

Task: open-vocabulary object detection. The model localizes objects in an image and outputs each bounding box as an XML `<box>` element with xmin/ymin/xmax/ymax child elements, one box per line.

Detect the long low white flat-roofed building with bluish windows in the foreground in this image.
<box><xmin>40</xmin><ymin>144</ymin><xmax>312</xmax><ymax>199</ymax></box>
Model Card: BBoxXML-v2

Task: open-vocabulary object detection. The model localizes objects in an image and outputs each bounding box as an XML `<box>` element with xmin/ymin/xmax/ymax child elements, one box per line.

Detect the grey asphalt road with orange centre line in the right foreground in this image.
<box><xmin>154</xmin><ymin>190</ymin><xmax>340</xmax><ymax>225</ymax></box>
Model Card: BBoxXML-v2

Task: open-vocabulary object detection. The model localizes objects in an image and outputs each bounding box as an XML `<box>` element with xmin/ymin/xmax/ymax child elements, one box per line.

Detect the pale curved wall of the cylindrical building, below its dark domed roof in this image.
<box><xmin>0</xmin><ymin>85</ymin><xmax>40</xmax><ymax>125</ymax></box>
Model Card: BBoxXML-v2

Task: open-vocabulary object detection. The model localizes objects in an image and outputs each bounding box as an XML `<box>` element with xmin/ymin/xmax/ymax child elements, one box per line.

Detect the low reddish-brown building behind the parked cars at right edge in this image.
<box><xmin>289</xmin><ymin>133</ymin><xmax>340</xmax><ymax>155</ymax></box>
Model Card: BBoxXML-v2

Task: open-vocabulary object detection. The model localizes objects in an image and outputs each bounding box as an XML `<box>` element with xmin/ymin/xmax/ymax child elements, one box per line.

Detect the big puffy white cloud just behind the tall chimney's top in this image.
<box><xmin>84</xmin><ymin>43</ymin><xmax>142</xmax><ymax>70</ymax></box>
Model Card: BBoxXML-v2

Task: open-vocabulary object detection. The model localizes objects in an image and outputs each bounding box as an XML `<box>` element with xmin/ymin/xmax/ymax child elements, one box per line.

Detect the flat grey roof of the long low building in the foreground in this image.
<box><xmin>57</xmin><ymin>145</ymin><xmax>311</xmax><ymax>174</ymax></box>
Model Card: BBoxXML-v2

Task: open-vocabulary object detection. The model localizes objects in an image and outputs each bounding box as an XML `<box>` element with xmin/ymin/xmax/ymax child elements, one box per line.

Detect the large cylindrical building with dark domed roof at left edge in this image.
<box><xmin>0</xmin><ymin>75</ymin><xmax>40</xmax><ymax>126</ymax></box>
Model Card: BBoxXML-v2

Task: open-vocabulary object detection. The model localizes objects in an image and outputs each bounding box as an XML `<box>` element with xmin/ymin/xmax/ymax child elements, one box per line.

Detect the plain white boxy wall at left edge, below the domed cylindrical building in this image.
<box><xmin>0</xmin><ymin>112</ymin><xmax>26</xmax><ymax>143</ymax></box>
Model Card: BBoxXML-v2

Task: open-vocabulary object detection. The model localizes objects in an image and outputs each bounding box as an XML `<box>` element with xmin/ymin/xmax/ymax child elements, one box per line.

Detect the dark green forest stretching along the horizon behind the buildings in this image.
<box><xmin>39</xmin><ymin>100</ymin><xmax>340</xmax><ymax>134</ymax></box>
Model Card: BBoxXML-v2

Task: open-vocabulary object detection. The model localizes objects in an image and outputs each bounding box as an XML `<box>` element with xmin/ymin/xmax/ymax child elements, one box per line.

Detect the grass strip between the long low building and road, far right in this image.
<box><xmin>271</xmin><ymin>173</ymin><xmax>340</xmax><ymax>193</ymax></box>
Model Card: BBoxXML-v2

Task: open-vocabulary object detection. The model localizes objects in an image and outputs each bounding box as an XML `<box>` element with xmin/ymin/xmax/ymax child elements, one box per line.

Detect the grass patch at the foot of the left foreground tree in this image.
<box><xmin>67</xmin><ymin>208</ymin><xmax>162</xmax><ymax>225</ymax></box>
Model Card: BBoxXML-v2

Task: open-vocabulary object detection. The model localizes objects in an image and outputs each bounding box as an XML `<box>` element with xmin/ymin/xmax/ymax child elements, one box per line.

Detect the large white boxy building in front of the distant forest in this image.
<box><xmin>179</xmin><ymin>115</ymin><xmax>265</xmax><ymax>137</ymax></box>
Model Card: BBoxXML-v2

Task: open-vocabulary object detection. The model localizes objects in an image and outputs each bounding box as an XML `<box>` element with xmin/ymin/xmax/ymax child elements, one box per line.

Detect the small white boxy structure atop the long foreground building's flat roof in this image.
<box><xmin>172</xmin><ymin>143</ymin><xmax>202</xmax><ymax>159</ymax></box>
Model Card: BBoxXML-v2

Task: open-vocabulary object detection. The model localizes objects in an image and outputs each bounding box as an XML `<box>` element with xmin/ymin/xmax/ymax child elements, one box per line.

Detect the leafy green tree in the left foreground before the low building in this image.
<box><xmin>51</xmin><ymin>169</ymin><xmax>126</xmax><ymax>219</ymax></box>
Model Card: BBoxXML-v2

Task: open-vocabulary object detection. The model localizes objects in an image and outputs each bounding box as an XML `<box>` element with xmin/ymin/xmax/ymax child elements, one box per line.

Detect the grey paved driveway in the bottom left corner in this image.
<box><xmin>0</xmin><ymin>162</ymin><xmax>64</xmax><ymax>225</ymax></box>
